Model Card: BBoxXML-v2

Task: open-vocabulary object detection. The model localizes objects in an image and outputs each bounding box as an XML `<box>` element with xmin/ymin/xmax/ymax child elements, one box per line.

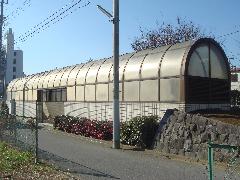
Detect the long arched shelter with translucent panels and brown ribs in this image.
<box><xmin>7</xmin><ymin>38</ymin><xmax>230</xmax><ymax>120</ymax></box>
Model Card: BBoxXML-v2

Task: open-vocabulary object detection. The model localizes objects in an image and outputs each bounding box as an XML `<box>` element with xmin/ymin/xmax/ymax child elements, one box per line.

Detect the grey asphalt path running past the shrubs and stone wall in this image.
<box><xmin>39</xmin><ymin>129</ymin><xmax>226</xmax><ymax>180</ymax></box>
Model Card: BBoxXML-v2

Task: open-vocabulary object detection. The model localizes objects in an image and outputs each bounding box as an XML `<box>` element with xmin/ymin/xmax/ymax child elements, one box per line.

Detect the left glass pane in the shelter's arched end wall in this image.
<box><xmin>188</xmin><ymin>44</ymin><xmax>209</xmax><ymax>77</ymax></box>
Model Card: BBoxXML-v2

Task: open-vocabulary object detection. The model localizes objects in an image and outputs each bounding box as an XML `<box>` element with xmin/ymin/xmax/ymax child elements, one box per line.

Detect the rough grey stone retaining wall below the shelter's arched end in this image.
<box><xmin>157</xmin><ymin>110</ymin><xmax>240</xmax><ymax>161</ymax></box>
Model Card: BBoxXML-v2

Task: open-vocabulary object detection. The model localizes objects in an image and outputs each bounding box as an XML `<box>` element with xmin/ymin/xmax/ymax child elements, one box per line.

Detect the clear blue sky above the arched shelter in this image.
<box><xmin>4</xmin><ymin>0</ymin><xmax>240</xmax><ymax>75</ymax></box>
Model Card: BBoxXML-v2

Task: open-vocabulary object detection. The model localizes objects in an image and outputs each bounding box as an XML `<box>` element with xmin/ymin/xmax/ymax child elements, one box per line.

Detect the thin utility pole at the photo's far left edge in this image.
<box><xmin>0</xmin><ymin>0</ymin><xmax>8</xmax><ymax>98</ymax></box>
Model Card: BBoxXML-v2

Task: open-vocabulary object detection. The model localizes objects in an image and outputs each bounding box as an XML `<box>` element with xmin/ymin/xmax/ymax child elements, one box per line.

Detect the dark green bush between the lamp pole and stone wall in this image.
<box><xmin>121</xmin><ymin>116</ymin><xmax>158</xmax><ymax>149</ymax></box>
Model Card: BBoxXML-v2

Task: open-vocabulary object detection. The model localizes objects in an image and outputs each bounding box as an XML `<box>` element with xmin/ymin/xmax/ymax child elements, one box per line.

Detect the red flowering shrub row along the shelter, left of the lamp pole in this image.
<box><xmin>54</xmin><ymin>116</ymin><xmax>113</xmax><ymax>140</ymax></box>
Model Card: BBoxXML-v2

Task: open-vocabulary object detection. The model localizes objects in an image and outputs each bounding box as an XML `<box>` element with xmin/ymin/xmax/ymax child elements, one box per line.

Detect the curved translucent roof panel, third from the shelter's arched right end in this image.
<box><xmin>124</xmin><ymin>50</ymin><xmax>150</xmax><ymax>80</ymax></box>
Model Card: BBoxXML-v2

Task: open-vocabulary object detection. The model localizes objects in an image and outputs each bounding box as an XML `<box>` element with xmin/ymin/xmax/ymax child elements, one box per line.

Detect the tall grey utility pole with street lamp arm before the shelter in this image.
<box><xmin>97</xmin><ymin>0</ymin><xmax>120</xmax><ymax>149</ymax></box>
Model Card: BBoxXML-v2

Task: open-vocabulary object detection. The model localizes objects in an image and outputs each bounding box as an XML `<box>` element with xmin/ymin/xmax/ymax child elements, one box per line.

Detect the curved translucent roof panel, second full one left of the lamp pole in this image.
<box><xmin>86</xmin><ymin>60</ymin><xmax>105</xmax><ymax>84</ymax></box>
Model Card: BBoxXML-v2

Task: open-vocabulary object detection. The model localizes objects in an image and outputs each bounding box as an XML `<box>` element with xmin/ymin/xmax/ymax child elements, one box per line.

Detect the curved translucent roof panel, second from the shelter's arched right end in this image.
<box><xmin>141</xmin><ymin>46</ymin><xmax>170</xmax><ymax>78</ymax></box>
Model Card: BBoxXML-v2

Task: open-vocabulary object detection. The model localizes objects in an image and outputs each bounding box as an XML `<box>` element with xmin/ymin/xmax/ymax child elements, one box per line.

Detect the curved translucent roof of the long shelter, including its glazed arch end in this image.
<box><xmin>8</xmin><ymin>38</ymin><xmax>230</xmax><ymax>91</ymax></box>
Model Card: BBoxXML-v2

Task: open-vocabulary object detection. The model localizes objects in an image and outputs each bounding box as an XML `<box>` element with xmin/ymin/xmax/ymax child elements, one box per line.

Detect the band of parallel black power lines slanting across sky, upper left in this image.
<box><xmin>15</xmin><ymin>0</ymin><xmax>90</xmax><ymax>43</ymax></box>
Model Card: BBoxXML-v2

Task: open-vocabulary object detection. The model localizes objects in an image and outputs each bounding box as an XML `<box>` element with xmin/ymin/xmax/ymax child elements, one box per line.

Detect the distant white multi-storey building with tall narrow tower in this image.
<box><xmin>5</xmin><ymin>28</ymin><xmax>24</xmax><ymax>86</ymax></box>
